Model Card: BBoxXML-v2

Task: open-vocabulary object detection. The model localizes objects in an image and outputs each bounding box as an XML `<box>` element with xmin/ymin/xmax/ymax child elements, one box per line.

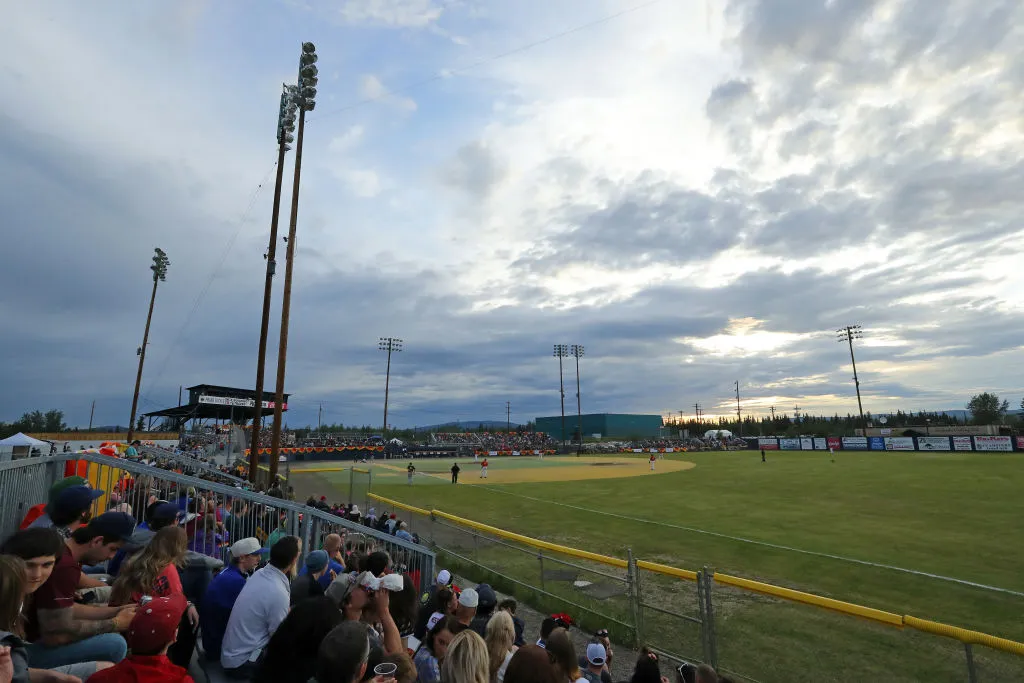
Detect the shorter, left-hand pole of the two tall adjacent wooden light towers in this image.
<box><xmin>247</xmin><ymin>85</ymin><xmax>298</xmax><ymax>483</ymax></box>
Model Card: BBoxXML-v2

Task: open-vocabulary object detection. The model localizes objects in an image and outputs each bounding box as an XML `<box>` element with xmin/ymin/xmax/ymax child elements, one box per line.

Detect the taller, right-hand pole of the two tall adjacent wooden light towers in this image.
<box><xmin>268</xmin><ymin>43</ymin><xmax>316</xmax><ymax>482</ymax></box>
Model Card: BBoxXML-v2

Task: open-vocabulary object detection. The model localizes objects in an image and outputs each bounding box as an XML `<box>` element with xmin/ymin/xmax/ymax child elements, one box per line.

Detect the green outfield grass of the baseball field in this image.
<box><xmin>290</xmin><ymin>452</ymin><xmax>1024</xmax><ymax>682</ymax></box>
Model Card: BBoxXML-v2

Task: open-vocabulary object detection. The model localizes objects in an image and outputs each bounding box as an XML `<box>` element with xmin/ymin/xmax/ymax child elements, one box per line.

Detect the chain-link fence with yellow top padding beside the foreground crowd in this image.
<box><xmin>369</xmin><ymin>493</ymin><xmax>1024</xmax><ymax>683</ymax></box>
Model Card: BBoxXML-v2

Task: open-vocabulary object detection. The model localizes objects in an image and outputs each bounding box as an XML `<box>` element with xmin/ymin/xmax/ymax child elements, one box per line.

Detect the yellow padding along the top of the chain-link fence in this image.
<box><xmin>368</xmin><ymin>494</ymin><xmax>1024</xmax><ymax>656</ymax></box>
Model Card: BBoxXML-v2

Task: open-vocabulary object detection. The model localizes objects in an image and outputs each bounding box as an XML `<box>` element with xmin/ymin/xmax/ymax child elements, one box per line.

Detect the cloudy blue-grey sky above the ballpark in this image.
<box><xmin>0</xmin><ymin>0</ymin><xmax>1024</xmax><ymax>426</ymax></box>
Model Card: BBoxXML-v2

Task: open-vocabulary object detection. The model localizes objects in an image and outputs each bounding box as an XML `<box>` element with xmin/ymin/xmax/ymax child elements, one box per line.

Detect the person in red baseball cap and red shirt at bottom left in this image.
<box><xmin>89</xmin><ymin>593</ymin><xmax>193</xmax><ymax>683</ymax></box>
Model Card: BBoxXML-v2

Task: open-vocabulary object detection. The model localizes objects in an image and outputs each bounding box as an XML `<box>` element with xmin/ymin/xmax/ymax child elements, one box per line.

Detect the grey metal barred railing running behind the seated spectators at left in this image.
<box><xmin>0</xmin><ymin>454</ymin><xmax>435</xmax><ymax>592</ymax></box>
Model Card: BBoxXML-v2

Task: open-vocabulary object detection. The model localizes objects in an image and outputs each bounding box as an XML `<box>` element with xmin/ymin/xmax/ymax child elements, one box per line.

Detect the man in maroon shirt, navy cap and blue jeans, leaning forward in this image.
<box><xmin>26</xmin><ymin>512</ymin><xmax>135</xmax><ymax>669</ymax></box>
